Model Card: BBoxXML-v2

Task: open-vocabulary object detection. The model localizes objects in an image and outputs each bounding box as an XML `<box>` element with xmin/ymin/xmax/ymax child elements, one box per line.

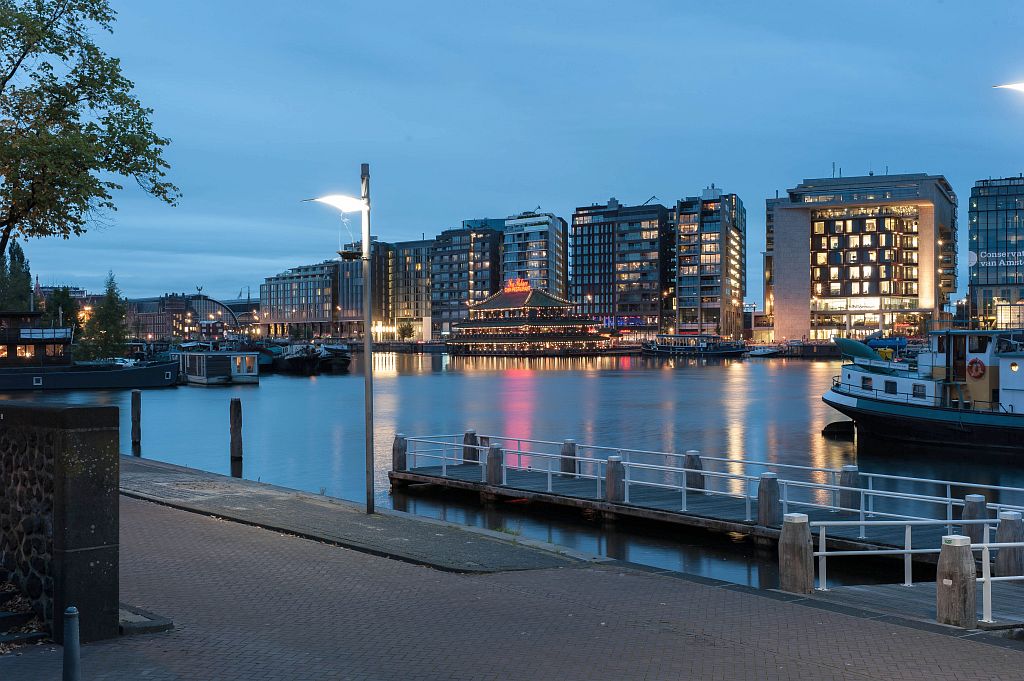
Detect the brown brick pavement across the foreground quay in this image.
<box><xmin>0</xmin><ymin>498</ymin><xmax>1024</xmax><ymax>681</ymax></box>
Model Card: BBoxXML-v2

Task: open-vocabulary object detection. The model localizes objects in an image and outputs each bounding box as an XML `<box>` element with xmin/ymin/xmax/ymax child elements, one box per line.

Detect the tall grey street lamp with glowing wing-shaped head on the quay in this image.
<box><xmin>310</xmin><ymin>163</ymin><xmax>374</xmax><ymax>513</ymax></box>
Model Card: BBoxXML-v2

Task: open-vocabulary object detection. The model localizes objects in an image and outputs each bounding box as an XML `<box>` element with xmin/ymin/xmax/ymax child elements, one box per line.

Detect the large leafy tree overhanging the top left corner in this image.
<box><xmin>0</xmin><ymin>0</ymin><xmax>178</xmax><ymax>253</ymax></box>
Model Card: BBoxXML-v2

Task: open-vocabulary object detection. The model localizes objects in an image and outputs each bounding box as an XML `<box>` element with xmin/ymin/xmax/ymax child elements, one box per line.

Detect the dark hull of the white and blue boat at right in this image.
<box><xmin>821</xmin><ymin>390</ymin><xmax>1024</xmax><ymax>455</ymax></box>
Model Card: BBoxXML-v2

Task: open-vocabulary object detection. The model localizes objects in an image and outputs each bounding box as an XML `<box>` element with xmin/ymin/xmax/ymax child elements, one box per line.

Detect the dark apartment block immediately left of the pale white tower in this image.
<box><xmin>430</xmin><ymin>225</ymin><xmax>504</xmax><ymax>336</ymax></box>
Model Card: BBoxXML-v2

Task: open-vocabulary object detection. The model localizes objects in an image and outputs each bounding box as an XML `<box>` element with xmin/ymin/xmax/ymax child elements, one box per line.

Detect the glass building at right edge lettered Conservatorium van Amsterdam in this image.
<box><xmin>966</xmin><ymin>177</ymin><xmax>1024</xmax><ymax>327</ymax></box>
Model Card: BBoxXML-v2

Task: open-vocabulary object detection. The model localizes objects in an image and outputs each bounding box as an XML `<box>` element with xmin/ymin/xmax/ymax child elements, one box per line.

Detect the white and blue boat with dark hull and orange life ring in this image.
<box><xmin>821</xmin><ymin>329</ymin><xmax>1024</xmax><ymax>454</ymax></box>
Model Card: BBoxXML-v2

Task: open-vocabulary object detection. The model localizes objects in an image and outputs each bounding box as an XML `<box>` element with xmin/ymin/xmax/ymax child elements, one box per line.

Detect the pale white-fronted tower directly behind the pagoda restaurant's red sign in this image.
<box><xmin>502</xmin><ymin>212</ymin><xmax>568</xmax><ymax>298</ymax></box>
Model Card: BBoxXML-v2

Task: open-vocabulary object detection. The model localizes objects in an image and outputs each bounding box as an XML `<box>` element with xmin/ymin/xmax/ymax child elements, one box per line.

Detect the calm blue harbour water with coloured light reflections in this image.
<box><xmin>6</xmin><ymin>354</ymin><xmax>1007</xmax><ymax>586</ymax></box>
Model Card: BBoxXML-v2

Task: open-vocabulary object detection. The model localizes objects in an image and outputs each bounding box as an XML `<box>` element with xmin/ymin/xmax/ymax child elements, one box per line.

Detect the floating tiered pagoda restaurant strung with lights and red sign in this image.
<box><xmin>447</xmin><ymin>280</ymin><xmax>609</xmax><ymax>355</ymax></box>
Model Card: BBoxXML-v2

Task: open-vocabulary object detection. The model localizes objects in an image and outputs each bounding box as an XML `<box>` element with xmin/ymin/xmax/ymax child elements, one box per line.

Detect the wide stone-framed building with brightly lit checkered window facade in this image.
<box><xmin>769</xmin><ymin>173</ymin><xmax>956</xmax><ymax>341</ymax></box>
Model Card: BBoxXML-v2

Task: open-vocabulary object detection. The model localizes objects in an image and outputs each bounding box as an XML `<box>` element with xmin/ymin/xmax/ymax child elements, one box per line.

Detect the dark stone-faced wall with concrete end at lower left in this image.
<box><xmin>0</xmin><ymin>402</ymin><xmax>120</xmax><ymax>642</ymax></box>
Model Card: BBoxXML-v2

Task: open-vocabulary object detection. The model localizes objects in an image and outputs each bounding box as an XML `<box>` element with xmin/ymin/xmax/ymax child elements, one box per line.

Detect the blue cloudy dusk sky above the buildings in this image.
<box><xmin>25</xmin><ymin>0</ymin><xmax>1024</xmax><ymax>303</ymax></box>
